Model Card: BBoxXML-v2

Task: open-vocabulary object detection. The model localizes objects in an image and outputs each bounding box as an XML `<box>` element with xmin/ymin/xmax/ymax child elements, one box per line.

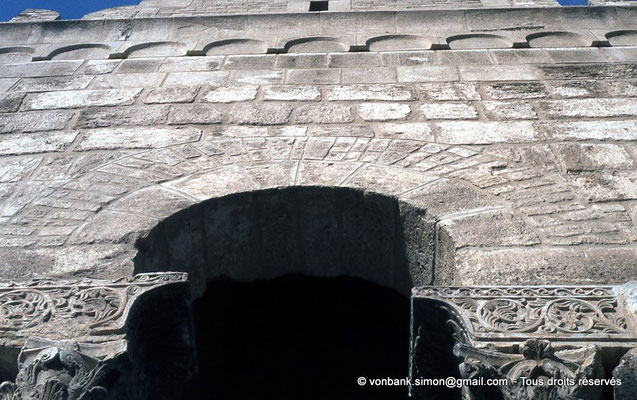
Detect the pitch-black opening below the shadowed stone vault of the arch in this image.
<box><xmin>184</xmin><ymin>275</ymin><xmax>410</xmax><ymax>400</ymax></box>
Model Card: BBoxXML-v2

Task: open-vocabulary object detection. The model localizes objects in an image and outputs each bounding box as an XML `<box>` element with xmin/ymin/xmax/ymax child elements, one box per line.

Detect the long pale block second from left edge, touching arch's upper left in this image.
<box><xmin>77</xmin><ymin>127</ymin><xmax>201</xmax><ymax>150</ymax></box>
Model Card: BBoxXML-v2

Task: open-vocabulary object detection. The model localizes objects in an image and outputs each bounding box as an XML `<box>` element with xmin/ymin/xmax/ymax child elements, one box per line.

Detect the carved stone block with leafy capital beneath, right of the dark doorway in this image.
<box><xmin>411</xmin><ymin>284</ymin><xmax>637</xmax><ymax>400</ymax></box>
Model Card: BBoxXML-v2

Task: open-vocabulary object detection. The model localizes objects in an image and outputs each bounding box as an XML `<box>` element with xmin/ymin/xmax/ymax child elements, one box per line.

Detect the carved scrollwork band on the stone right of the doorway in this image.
<box><xmin>414</xmin><ymin>286</ymin><xmax>636</xmax><ymax>342</ymax></box>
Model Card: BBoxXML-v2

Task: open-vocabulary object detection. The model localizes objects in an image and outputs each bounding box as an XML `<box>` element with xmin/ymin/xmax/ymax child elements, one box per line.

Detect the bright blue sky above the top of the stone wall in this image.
<box><xmin>0</xmin><ymin>0</ymin><xmax>587</xmax><ymax>21</ymax></box>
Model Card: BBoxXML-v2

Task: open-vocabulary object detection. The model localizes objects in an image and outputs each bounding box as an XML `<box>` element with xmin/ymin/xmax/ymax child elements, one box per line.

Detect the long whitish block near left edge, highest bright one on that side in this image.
<box><xmin>24</xmin><ymin>89</ymin><xmax>142</xmax><ymax>110</ymax></box>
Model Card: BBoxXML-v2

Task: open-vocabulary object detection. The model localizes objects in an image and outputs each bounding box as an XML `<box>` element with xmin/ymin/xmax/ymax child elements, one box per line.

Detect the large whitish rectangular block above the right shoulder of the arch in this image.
<box><xmin>437</xmin><ymin>121</ymin><xmax>540</xmax><ymax>144</ymax></box>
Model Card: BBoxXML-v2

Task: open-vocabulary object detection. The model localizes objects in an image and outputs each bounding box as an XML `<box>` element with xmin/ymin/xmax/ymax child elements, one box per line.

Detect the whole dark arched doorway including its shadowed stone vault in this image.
<box><xmin>135</xmin><ymin>187</ymin><xmax>435</xmax><ymax>400</ymax></box>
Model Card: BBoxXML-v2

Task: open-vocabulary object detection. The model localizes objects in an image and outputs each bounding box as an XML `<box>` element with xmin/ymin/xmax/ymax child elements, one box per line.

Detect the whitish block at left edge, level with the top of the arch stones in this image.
<box><xmin>0</xmin><ymin>131</ymin><xmax>77</xmax><ymax>155</ymax></box>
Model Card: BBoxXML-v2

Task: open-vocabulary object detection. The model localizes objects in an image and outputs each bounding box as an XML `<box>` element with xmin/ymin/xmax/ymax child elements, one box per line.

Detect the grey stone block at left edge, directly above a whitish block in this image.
<box><xmin>0</xmin><ymin>111</ymin><xmax>73</xmax><ymax>133</ymax></box>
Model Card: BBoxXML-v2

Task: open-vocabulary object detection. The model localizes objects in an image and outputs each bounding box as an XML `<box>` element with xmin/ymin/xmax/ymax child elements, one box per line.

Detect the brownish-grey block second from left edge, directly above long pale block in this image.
<box><xmin>75</xmin><ymin>105</ymin><xmax>169</xmax><ymax>129</ymax></box>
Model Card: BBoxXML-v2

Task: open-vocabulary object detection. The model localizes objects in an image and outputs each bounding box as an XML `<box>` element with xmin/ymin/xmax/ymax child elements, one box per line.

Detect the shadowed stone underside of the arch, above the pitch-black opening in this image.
<box><xmin>135</xmin><ymin>187</ymin><xmax>435</xmax><ymax>298</ymax></box>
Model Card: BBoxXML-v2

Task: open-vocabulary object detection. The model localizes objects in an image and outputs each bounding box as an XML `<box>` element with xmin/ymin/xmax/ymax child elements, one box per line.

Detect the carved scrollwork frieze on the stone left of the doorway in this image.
<box><xmin>0</xmin><ymin>273</ymin><xmax>187</xmax><ymax>343</ymax></box>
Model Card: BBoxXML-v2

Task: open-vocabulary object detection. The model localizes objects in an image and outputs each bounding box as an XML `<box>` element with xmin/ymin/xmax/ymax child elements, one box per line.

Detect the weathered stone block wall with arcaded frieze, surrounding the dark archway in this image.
<box><xmin>0</xmin><ymin>0</ymin><xmax>637</xmax><ymax>398</ymax></box>
